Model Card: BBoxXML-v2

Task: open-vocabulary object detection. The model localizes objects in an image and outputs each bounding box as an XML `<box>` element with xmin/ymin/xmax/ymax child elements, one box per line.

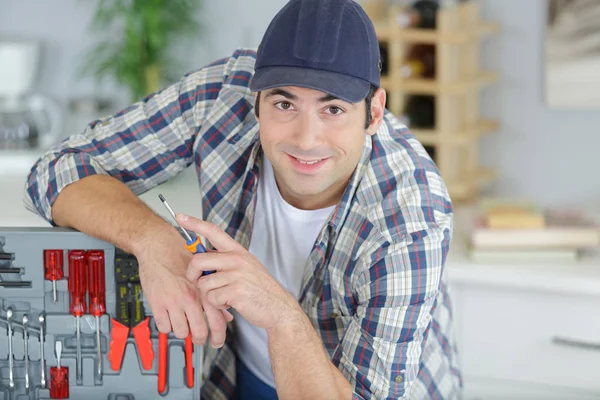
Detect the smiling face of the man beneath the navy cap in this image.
<box><xmin>258</xmin><ymin>86</ymin><xmax>385</xmax><ymax>209</ymax></box>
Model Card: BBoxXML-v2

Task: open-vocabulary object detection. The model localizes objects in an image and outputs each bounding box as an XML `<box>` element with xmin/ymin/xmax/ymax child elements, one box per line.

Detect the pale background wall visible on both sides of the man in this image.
<box><xmin>0</xmin><ymin>0</ymin><xmax>600</xmax><ymax>204</ymax></box>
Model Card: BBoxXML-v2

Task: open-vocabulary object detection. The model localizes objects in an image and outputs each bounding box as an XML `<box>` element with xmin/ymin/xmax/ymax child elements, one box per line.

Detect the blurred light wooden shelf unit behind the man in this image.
<box><xmin>362</xmin><ymin>0</ymin><xmax>500</xmax><ymax>203</ymax></box>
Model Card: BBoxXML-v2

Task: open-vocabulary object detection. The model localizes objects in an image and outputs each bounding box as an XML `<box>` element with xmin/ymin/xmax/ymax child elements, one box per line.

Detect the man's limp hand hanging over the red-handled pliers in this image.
<box><xmin>136</xmin><ymin>231</ymin><xmax>233</xmax><ymax>347</ymax></box>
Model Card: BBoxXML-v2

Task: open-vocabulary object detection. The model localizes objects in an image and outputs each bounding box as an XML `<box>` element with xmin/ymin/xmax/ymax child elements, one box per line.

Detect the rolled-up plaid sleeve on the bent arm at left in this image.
<box><xmin>24</xmin><ymin>54</ymin><xmax>234</xmax><ymax>223</ymax></box>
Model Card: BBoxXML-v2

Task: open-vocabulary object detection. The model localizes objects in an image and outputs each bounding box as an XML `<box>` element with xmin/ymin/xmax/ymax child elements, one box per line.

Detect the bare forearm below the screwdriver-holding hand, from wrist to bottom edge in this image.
<box><xmin>267</xmin><ymin>312</ymin><xmax>352</xmax><ymax>400</ymax></box>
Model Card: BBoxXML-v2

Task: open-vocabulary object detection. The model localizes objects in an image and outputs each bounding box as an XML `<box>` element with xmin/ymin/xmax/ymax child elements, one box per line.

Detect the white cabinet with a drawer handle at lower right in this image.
<box><xmin>447</xmin><ymin>236</ymin><xmax>600</xmax><ymax>400</ymax></box>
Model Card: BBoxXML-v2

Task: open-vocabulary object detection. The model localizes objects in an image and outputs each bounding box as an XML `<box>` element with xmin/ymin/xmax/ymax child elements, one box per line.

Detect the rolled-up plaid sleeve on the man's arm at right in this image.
<box><xmin>332</xmin><ymin>227</ymin><xmax>451</xmax><ymax>399</ymax></box>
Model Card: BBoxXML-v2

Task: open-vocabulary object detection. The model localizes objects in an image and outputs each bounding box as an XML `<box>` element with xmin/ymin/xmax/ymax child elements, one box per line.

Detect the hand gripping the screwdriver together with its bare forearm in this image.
<box><xmin>177</xmin><ymin>215</ymin><xmax>352</xmax><ymax>399</ymax></box>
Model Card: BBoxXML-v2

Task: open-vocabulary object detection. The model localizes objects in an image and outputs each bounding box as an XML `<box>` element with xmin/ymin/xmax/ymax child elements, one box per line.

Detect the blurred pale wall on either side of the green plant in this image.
<box><xmin>0</xmin><ymin>0</ymin><xmax>286</xmax><ymax>106</ymax></box>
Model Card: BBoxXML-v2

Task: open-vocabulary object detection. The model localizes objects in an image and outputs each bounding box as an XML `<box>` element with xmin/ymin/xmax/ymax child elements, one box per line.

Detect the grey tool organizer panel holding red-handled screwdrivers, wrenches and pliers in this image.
<box><xmin>0</xmin><ymin>228</ymin><xmax>202</xmax><ymax>400</ymax></box>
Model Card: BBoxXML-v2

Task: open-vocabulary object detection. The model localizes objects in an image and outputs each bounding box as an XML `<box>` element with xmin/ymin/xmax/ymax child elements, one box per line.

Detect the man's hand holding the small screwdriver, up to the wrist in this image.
<box><xmin>177</xmin><ymin>214</ymin><xmax>303</xmax><ymax>331</ymax></box>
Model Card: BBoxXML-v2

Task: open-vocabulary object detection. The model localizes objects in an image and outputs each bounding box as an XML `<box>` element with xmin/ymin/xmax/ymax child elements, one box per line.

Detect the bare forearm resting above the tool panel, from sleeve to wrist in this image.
<box><xmin>52</xmin><ymin>175</ymin><xmax>181</xmax><ymax>255</ymax></box>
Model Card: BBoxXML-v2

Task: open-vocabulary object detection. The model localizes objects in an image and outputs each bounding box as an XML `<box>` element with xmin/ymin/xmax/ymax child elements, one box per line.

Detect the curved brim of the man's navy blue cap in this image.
<box><xmin>250</xmin><ymin>66</ymin><xmax>371</xmax><ymax>103</ymax></box>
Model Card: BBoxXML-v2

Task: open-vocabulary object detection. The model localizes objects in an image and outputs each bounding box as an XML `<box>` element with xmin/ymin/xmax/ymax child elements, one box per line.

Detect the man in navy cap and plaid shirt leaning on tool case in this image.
<box><xmin>27</xmin><ymin>0</ymin><xmax>461</xmax><ymax>399</ymax></box>
